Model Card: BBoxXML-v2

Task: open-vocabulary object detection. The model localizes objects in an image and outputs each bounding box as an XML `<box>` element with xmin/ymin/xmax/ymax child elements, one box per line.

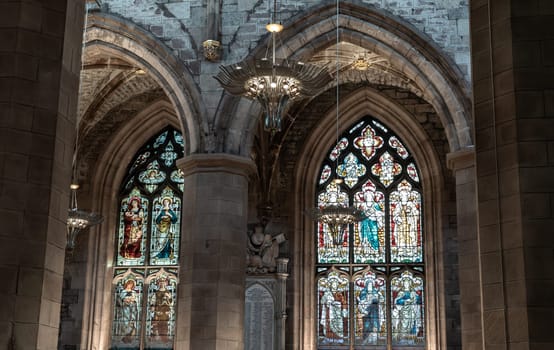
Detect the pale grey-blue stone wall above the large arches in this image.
<box><xmin>97</xmin><ymin>0</ymin><xmax>471</xmax><ymax>81</ymax></box>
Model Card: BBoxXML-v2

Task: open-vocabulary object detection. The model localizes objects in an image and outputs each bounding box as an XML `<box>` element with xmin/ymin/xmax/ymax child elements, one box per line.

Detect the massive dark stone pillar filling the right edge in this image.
<box><xmin>471</xmin><ymin>0</ymin><xmax>554</xmax><ymax>349</ymax></box>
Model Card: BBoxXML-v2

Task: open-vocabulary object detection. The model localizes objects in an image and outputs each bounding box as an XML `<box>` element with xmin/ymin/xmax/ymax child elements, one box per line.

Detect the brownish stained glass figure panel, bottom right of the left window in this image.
<box><xmin>145</xmin><ymin>269</ymin><xmax>177</xmax><ymax>350</ymax></box>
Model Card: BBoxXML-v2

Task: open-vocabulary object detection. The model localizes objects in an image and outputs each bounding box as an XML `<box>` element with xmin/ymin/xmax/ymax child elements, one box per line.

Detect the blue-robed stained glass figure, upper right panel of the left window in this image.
<box><xmin>150</xmin><ymin>187</ymin><xmax>181</xmax><ymax>265</ymax></box>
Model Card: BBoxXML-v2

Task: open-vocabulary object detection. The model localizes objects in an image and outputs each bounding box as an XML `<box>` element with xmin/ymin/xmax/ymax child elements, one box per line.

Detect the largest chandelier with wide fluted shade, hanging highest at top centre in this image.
<box><xmin>214</xmin><ymin>0</ymin><xmax>331</xmax><ymax>134</ymax></box>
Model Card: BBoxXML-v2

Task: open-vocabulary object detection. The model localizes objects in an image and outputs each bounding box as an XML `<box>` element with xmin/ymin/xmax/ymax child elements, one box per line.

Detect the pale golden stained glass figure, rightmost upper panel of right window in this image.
<box><xmin>390</xmin><ymin>180</ymin><xmax>423</xmax><ymax>263</ymax></box>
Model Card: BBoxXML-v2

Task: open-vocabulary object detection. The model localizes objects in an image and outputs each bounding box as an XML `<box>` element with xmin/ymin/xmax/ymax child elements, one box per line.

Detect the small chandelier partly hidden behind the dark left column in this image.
<box><xmin>66</xmin><ymin>183</ymin><xmax>104</xmax><ymax>250</ymax></box>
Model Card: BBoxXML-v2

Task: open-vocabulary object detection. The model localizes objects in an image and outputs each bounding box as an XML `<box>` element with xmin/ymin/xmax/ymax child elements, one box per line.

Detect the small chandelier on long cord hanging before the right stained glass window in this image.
<box><xmin>307</xmin><ymin>0</ymin><xmax>365</xmax><ymax>235</ymax></box>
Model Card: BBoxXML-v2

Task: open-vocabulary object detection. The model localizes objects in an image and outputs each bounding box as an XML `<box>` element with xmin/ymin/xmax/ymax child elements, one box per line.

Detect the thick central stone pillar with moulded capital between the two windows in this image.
<box><xmin>175</xmin><ymin>154</ymin><xmax>255</xmax><ymax>350</ymax></box>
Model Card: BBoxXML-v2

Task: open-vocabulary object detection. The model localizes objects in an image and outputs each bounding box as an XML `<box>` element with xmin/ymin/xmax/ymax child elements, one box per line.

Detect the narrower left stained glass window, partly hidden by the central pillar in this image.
<box><xmin>110</xmin><ymin>127</ymin><xmax>184</xmax><ymax>350</ymax></box>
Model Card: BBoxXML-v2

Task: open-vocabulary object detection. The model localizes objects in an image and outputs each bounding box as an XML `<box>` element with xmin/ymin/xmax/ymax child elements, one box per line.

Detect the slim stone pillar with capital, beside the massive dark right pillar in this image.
<box><xmin>447</xmin><ymin>150</ymin><xmax>482</xmax><ymax>350</ymax></box>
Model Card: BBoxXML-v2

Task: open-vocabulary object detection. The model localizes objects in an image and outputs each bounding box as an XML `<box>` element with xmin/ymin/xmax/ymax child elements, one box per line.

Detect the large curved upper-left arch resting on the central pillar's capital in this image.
<box><xmin>84</xmin><ymin>12</ymin><xmax>208</xmax><ymax>154</ymax></box>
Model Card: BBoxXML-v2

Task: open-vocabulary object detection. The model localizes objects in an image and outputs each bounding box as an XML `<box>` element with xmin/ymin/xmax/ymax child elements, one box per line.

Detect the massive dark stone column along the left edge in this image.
<box><xmin>0</xmin><ymin>0</ymin><xmax>85</xmax><ymax>350</ymax></box>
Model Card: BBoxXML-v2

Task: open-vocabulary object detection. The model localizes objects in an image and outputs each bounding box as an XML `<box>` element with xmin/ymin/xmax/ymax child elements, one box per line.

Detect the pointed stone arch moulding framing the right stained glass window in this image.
<box><xmin>290</xmin><ymin>88</ymin><xmax>446</xmax><ymax>349</ymax></box>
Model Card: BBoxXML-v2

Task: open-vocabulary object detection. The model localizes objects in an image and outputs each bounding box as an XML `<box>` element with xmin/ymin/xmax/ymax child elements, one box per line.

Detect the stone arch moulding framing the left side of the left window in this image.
<box><xmin>81</xmin><ymin>100</ymin><xmax>179</xmax><ymax>349</ymax></box>
